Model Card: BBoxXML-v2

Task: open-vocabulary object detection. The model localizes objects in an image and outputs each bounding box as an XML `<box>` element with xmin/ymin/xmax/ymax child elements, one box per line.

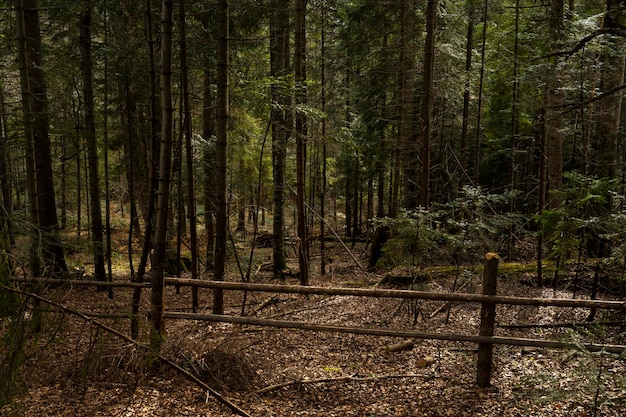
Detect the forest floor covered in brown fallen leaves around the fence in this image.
<box><xmin>0</xmin><ymin>237</ymin><xmax>626</xmax><ymax>417</ymax></box>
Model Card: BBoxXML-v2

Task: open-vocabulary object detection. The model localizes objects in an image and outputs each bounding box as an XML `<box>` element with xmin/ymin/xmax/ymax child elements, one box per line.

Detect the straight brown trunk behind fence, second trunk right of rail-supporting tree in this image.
<box><xmin>213</xmin><ymin>0</ymin><xmax>229</xmax><ymax>314</ymax></box>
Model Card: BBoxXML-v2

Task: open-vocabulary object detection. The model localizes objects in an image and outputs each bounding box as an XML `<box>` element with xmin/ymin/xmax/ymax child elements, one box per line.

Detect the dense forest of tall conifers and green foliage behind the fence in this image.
<box><xmin>0</xmin><ymin>0</ymin><xmax>626</xmax><ymax>412</ymax></box>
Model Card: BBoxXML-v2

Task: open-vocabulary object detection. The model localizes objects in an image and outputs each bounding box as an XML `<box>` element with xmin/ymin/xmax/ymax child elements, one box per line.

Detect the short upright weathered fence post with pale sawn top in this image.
<box><xmin>476</xmin><ymin>252</ymin><xmax>500</xmax><ymax>388</ymax></box>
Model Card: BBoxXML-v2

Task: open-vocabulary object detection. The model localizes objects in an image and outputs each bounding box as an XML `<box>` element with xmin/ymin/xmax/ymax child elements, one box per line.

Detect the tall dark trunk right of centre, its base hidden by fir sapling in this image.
<box><xmin>420</xmin><ymin>0</ymin><xmax>439</xmax><ymax>208</ymax></box>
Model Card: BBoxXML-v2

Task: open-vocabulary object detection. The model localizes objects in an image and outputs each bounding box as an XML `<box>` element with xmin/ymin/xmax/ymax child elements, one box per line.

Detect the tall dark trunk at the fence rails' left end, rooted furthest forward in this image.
<box><xmin>150</xmin><ymin>0</ymin><xmax>173</xmax><ymax>351</ymax></box>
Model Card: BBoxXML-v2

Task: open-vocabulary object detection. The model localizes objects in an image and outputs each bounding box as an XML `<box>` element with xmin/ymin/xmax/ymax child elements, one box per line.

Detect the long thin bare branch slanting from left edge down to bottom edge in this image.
<box><xmin>0</xmin><ymin>285</ymin><xmax>252</xmax><ymax>417</ymax></box>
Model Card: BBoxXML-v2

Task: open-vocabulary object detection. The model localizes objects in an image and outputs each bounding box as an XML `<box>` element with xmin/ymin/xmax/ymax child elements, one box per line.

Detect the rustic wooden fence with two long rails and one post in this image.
<box><xmin>8</xmin><ymin>253</ymin><xmax>626</xmax><ymax>387</ymax></box>
